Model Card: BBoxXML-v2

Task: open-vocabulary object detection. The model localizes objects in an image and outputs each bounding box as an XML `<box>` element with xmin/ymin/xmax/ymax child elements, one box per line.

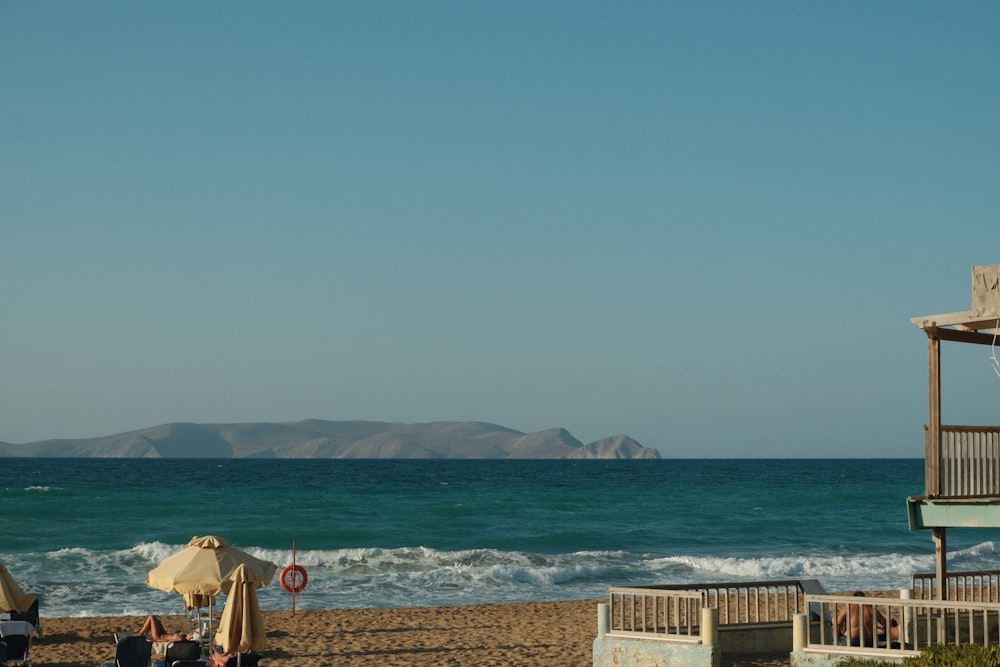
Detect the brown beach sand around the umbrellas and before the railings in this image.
<box><xmin>25</xmin><ymin>600</ymin><xmax>788</xmax><ymax>667</ymax></box>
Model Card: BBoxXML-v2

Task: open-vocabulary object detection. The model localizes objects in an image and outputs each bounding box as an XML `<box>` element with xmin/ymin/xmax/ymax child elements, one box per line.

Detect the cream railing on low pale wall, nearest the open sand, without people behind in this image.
<box><xmin>609</xmin><ymin>580</ymin><xmax>818</xmax><ymax>641</ymax></box>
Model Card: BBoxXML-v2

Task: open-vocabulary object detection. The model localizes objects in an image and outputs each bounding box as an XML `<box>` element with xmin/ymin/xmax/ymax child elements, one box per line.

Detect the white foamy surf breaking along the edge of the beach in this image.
<box><xmin>11</xmin><ymin>542</ymin><xmax>998</xmax><ymax>616</ymax></box>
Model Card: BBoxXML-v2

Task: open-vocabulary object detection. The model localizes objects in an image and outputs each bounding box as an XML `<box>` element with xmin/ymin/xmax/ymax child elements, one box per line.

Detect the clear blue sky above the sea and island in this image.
<box><xmin>0</xmin><ymin>0</ymin><xmax>1000</xmax><ymax>457</ymax></box>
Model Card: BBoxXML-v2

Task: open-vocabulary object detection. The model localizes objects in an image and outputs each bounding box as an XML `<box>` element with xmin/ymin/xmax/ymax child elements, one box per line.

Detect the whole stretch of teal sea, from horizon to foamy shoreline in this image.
<box><xmin>0</xmin><ymin>458</ymin><xmax>1000</xmax><ymax>616</ymax></box>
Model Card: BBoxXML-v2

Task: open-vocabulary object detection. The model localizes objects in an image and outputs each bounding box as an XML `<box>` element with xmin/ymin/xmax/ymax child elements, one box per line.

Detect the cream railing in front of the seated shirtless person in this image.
<box><xmin>804</xmin><ymin>595</ymin><xmax>1000</xmax><ymax>658</ymax></box>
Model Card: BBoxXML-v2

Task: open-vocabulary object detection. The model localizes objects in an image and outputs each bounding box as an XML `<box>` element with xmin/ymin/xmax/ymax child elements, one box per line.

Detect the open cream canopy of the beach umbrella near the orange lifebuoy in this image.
<box><xmin>146</xmin><ymin>535</ymin><xmax>278</xmax><ymax>595</ymax></box>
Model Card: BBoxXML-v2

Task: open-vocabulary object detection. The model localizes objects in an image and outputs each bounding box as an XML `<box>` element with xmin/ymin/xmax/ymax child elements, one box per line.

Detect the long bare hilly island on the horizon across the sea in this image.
<box><xmin>0</xmin><ymin>419</ymin><xmax>660</xmax><ymax>459</ymax></box>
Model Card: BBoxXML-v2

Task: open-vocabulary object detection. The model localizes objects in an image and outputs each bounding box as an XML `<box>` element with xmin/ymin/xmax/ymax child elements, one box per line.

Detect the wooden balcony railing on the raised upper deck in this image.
<box><xmin>924</xmin><ymin>425</ymin><xmax>1000</xmax><ymax>498</ymax></box>
